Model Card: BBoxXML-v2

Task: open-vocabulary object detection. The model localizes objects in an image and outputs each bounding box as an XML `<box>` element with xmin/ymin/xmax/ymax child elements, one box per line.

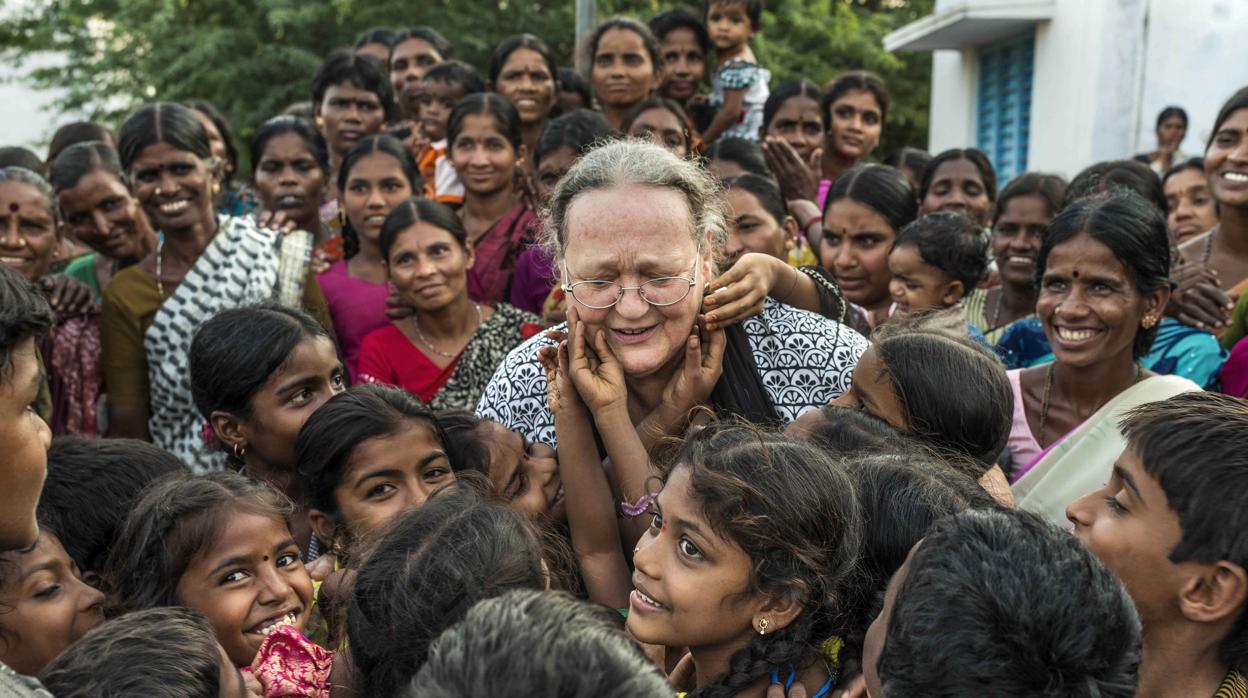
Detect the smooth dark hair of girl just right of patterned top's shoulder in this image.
<box><xmin>872</xmin><ymin>327</ymin><xmax>1013</xmax><ymax>476</ymax></box>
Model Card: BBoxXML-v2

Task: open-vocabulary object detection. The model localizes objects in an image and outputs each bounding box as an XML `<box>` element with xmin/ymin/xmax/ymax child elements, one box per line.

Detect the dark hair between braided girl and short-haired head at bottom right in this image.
<box><xmin>844</xmin><ymin>457</ymin><xmax>996</xmax><ymax>647</ymax></box>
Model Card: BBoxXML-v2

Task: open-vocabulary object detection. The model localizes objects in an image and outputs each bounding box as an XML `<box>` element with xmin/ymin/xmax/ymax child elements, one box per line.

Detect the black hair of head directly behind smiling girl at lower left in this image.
<box><xmin>39</xmin><ymin>436</ymin><xmax>190</xmax><ymax>573</ymax></box>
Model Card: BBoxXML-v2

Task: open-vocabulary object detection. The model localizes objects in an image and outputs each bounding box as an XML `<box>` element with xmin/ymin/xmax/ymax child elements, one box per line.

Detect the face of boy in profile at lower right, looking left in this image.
<box><xmin>1066</xmin><ymin>446</ymin><xmax>1194</xmax><ymax>627</ymax></box>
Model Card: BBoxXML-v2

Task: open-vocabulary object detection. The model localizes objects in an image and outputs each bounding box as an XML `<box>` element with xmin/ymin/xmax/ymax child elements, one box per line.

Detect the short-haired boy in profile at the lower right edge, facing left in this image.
<box><xmin>1066</xmin><ymin>392</ymin><xmax>1248</xmax><ymax>698</ymax></box>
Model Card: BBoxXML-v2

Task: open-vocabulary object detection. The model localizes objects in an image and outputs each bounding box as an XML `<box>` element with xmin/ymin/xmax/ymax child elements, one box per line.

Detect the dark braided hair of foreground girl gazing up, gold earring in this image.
<box><xmin>664</xmin><ymin>423</ymin><xmax>862</xmax><ymax>698</ymax></box>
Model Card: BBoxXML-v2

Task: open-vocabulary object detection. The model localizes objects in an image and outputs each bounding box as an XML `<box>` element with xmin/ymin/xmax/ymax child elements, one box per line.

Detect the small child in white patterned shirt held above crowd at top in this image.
<box><xmin>703</xmin><ymin>0</ymin><xmax>771</xmax><ymax>145</ymax></box>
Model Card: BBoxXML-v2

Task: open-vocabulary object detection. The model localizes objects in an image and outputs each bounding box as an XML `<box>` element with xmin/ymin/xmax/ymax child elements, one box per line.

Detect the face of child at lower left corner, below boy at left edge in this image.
<box><xmin>0</xmin><ymin>529</ymin><xmax>104</xmax><ymax>676</ymax></box>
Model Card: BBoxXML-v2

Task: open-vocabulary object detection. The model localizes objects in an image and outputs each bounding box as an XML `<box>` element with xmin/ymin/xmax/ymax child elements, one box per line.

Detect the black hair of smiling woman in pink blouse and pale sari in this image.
<box><xmin>1036</xmin><ymin>190</ymin><xmax>1171</xmax><ymax>358</ymax></box>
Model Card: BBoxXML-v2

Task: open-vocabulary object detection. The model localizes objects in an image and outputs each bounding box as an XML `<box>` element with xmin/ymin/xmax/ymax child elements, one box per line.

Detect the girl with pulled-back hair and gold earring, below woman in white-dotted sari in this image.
<box><xmin>191</xmin><ymin>305</ymin><xmax>347</xmax><ymax>561</ymax></box>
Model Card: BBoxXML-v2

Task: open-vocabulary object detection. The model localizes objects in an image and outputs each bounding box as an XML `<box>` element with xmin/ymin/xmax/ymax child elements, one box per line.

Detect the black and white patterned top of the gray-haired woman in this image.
<box><xmin>477</xmin><ymin>298</ymin><xmax>869</xmax><ymax>446</ymax></box>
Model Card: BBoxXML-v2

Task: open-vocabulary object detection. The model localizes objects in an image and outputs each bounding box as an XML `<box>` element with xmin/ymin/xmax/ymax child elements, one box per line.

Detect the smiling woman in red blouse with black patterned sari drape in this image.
<box><xmin>359</xmin><ymin>198</ymin><xmax>542</xmax><ymax>410</ymax></box>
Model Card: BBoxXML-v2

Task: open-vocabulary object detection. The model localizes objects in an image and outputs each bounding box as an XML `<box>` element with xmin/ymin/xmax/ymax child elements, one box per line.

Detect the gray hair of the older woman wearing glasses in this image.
<box><xmin>543</xmin><ymin>139</ymin><xmax>728</xmax><ymax>260</ymax></box>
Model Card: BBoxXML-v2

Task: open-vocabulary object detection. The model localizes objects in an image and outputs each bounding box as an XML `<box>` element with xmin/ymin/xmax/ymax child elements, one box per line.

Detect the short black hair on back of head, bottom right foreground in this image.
<box><xmin>879</xmin><ymin>508</ymin><xmax>1139</xmax><ymax>698</ymax></box>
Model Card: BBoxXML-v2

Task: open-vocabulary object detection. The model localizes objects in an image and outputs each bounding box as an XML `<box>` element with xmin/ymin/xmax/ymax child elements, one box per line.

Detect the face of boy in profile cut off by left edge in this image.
<box><xmin>0</xmin><ymin>338</ymin><xmax>52</xmax><ymax>552</ymax></box>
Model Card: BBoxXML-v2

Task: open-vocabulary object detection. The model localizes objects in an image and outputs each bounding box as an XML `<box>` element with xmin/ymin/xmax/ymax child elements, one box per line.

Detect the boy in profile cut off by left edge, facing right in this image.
<box><xmin>0</xmin><ymin>265</ymin><xmax>52</xmax><ymax>697</ymax></box>
